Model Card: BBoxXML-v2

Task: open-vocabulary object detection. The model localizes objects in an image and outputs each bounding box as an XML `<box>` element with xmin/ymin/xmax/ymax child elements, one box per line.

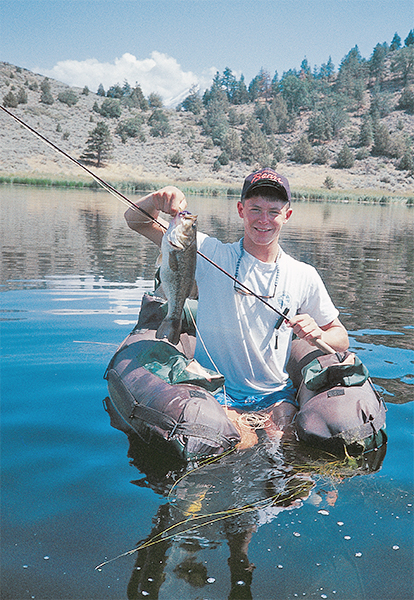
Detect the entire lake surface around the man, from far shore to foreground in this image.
<box><xmin>0</xmin><ymin>186</ymin><xmax>414</xmax><ymax>600</ymax></box>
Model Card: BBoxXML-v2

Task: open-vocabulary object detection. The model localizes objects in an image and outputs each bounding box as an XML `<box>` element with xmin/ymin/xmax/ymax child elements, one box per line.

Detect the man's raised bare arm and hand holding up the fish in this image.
<box><xmin>124</xmin><ymin>186</ymin><xmax>187</xmax><ymax>246</ymax></box>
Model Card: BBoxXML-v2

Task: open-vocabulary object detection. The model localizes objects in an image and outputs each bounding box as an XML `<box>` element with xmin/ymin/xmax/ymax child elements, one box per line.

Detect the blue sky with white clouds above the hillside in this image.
<box><xmin>0</xmin><ymin>0</ymin><xmax>414</xmax><ymax>105</ymax></box>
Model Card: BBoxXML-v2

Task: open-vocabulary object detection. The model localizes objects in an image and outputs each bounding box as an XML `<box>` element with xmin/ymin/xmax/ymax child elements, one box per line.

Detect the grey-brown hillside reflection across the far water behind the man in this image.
<box><xmin>1</xmin><ymin>190</ymin><xmax>414</xmax><ymax>347</ymax></box>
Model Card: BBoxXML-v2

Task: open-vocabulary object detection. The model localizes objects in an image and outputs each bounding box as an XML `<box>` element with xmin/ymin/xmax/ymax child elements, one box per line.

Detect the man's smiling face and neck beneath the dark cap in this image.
<box><xmin>237</xmin><ymin>195</ymin><xmax>292</xmax><ymax>262</ymax></box>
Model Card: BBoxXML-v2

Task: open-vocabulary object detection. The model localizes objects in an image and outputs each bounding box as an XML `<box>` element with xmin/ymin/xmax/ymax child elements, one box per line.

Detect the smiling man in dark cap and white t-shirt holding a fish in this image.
<box><xmin>125</xmin><ymin>168</ymin><xmax>348</xmax><ymax>445</ymax></box>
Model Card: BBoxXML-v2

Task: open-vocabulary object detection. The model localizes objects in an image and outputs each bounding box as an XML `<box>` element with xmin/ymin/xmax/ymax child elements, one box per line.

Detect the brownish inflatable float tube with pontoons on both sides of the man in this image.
<box><xmin>104</xmin><ymin>295</ymin><xmax>387</xmax><ymax>461</ymax></box>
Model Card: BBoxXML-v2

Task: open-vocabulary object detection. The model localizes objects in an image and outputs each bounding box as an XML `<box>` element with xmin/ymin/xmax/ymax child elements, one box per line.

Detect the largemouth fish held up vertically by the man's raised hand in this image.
<box><xmin>155</xmin><ymin>211</ymin><xmax>197</xmax><ymax>344</ymax></box>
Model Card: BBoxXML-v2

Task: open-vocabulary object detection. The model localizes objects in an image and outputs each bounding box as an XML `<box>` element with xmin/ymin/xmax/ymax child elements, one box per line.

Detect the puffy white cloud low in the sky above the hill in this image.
<box><xmin>34</xmin><ymin>50</ymin><xmax>216</xmax><ymax>106</ymax></box>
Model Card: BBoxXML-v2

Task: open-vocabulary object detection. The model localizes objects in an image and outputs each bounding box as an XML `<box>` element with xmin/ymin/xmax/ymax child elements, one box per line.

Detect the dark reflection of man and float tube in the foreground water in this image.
<box><xmin>119</xmin><ymin>432</ymin><xmax>386</xmax><ymax>600</ymax></box>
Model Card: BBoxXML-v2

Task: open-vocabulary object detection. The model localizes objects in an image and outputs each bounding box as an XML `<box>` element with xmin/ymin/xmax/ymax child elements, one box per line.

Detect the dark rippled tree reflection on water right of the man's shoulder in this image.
<box><xmin>283</xmin><ymin>218</ymin><xmax>414</xmax><ymax>347</ymax></box>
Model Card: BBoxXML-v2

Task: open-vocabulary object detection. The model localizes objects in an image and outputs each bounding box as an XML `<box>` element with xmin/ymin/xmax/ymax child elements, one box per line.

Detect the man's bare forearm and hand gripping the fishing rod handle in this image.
<box><xmin>289</xmin><ymin>314</ymin><xmax>349</xmax><ymax>352</ymax></box>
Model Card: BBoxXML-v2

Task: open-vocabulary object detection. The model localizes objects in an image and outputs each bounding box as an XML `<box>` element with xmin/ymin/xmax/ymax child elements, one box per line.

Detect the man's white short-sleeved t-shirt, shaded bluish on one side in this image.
<box><xmin>195</xmin><ymin>233</ymin><xmax>339</xmax><ymax>399</ymax></box>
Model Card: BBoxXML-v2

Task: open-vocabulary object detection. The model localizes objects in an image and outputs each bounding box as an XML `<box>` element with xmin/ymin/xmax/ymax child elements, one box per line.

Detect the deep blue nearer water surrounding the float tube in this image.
<box><xmin>1</xmin><ymin>189</ymin><xmax>414</xmax><ymax>600</ymax></box>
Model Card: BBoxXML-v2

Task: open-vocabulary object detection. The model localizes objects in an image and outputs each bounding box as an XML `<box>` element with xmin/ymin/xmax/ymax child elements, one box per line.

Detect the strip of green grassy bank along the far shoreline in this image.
<box><xmin>0</xmin><ymin>176</ymin><xmax>414</xmax><ymax>206</ymax></box>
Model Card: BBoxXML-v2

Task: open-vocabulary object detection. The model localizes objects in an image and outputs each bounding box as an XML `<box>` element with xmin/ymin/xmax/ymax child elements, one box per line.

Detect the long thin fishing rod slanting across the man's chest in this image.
<box><xmin>0</xmin><ymin>104</ymin><xmax>335</xmax><ymax>354</ymax></box>
